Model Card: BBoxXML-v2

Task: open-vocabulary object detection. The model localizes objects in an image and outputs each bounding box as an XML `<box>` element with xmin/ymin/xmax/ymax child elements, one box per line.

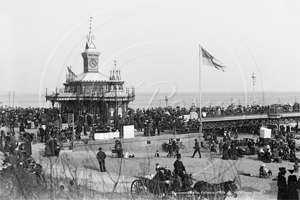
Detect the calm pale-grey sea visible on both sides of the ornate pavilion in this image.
<box><xmin>0</xmin><ymin>91</ymin><xmax>300</xmax><ymax>109</ymax></box>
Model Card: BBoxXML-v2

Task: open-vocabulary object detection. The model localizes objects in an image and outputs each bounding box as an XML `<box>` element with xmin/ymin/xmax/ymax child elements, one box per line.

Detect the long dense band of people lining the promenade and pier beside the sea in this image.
<box><xmin>0</xmin><ymin>103</ymin><xmax>299</xmax><ymax>145</ymax></box>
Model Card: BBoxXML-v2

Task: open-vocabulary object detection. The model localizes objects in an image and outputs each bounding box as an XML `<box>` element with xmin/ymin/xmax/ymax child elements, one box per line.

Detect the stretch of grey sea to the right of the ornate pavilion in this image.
<box><xmin>130</xmin><ymin>92</ymin><xmax>300</xmax><ymax>108</ymax></box>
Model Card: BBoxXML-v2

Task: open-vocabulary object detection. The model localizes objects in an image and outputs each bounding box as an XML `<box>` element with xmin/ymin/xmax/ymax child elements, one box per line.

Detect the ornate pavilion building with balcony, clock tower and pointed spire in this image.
<box><xmin>46</xmin><ymin>17</ymin><xmax>135</xmax><ymax>123</ymax></box>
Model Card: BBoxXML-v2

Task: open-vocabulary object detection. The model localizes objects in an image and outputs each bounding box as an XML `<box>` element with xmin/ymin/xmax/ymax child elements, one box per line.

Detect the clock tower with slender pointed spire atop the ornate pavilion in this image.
<box><xmin>81</xmin><ymin>17</ymin><xmax>100</xmax><ymax>73</ymax></box>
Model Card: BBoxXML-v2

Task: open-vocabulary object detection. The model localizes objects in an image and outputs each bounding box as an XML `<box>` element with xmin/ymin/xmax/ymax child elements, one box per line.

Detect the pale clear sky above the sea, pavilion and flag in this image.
<box><xmin>0</xmin><ymin>0</ymin><xmax>300</xmax><ymax>97</ymax></box>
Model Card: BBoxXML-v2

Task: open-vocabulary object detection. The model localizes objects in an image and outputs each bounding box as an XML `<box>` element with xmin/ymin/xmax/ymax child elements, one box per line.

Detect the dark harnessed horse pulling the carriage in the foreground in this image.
<box><xmin>193</xmin><ymin>179</ymin><xmax>237</xmax><ymax>200</ymax></box>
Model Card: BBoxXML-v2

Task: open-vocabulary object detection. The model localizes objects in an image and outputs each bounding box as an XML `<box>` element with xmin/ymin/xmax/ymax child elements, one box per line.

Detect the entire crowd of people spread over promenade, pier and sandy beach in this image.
<box><xmin>0</xmin><ymin>103</ymin><xmax>299</xmax><ymax>198</ymax></box>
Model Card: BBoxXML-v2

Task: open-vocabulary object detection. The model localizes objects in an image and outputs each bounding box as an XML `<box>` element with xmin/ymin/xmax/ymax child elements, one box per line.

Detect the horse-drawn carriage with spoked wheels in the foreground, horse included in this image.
<box><xmin>130</xmin><ymin>173</ymin><xmax>237</xmax><ymax>200</ymax></box>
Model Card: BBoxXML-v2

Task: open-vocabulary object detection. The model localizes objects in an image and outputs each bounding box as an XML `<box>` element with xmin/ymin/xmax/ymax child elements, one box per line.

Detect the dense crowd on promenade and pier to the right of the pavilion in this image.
<box><xmin>125</xmin><ymin>103</ymin><xmax>300</xmax><ymax>136</ymax></box>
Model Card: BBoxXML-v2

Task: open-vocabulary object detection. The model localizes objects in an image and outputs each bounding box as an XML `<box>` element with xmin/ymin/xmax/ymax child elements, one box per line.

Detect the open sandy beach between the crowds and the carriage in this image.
<box><xmin>12</xmin><ymin>129</ymin><xmax>300</xmax><ymax>199</ymax></box>
